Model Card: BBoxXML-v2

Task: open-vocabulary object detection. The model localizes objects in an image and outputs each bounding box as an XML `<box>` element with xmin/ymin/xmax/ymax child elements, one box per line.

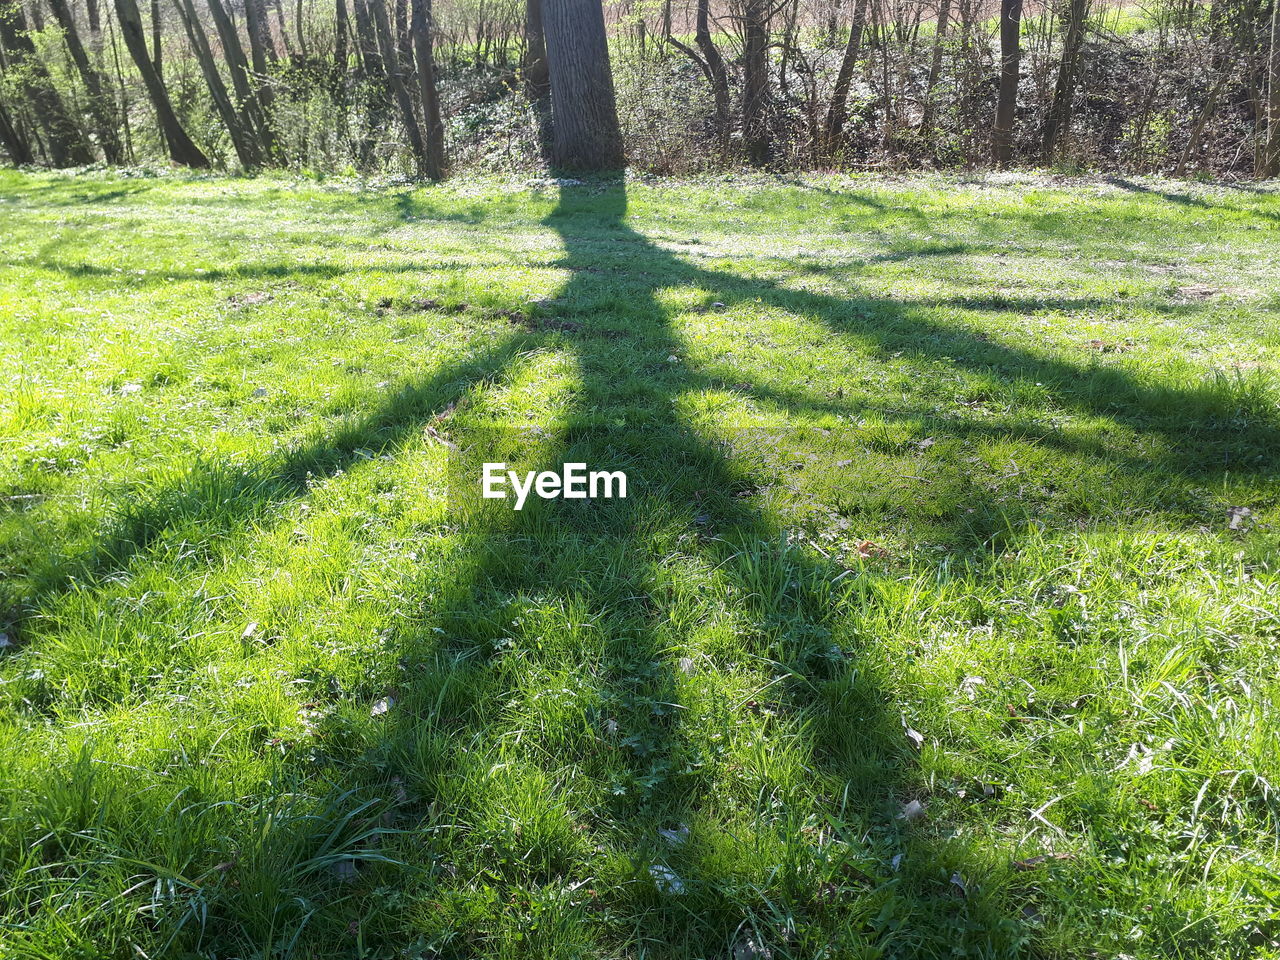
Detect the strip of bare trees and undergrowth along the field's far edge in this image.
<box><xmin>0</xmin><ymin>0</ymin><xmax>1280</xmax><ymax>179</ymax></box>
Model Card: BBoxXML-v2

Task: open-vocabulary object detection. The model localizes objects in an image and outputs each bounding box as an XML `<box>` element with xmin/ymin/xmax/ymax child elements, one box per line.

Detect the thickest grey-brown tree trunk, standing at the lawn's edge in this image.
<box><xmin>543</xmin><ymin>0</ymin><xmax>626</xmax><ymax>170</ymax></box>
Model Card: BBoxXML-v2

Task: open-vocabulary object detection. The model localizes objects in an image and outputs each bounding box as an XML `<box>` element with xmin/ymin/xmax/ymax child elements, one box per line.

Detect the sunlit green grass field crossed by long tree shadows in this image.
<box><xmin>0</xmin><ymin>173</ymin><xmax>1280</xmax><ymax>960</ymax></box>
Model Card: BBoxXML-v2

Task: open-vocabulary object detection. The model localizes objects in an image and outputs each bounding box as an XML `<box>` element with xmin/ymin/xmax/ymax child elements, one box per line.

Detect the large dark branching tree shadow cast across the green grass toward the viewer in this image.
<box><xmin>2</xmin><ymin>176</ymin><xmax>1277</xmax><ymax>956</ymax></box>
